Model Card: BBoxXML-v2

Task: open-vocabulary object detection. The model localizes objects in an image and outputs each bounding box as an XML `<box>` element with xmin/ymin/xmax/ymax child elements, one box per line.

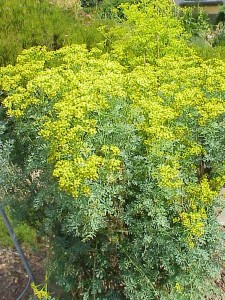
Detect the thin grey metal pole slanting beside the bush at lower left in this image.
<box><xmin>0</xmin><ymin>208</ymin><xmax>36</xmax><ymax>299</ymax></box>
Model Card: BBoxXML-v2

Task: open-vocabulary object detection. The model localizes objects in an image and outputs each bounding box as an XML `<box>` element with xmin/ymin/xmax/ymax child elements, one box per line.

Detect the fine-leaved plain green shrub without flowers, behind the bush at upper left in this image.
<box><xmin>0</xmin><ymin>0</ymin><xmax>102</xmax><ymax>65</ymax></box>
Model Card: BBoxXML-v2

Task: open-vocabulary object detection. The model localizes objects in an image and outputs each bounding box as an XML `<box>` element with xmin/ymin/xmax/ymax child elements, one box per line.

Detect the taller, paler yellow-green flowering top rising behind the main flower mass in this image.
<box><xmin>99</xmin><ymin>1</ymin><xmax>190</xmax><ymax>68</ymax></box>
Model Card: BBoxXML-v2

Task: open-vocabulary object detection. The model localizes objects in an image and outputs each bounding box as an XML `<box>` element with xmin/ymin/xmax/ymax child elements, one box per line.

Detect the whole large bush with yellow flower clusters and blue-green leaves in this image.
<box><xmin>0</xmin><ymin>0</ymin><xmax>225</xmax><ymax>300</ymax></box>
